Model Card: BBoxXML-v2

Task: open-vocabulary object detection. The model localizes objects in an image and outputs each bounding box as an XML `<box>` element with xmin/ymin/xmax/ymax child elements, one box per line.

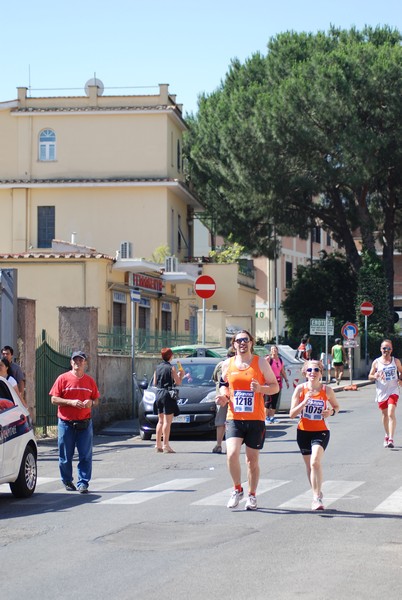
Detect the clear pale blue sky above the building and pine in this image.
<box><xmin>0</xmin><ymin>0</ymin><xmax>402</xmax><ymax>115</ymax></box>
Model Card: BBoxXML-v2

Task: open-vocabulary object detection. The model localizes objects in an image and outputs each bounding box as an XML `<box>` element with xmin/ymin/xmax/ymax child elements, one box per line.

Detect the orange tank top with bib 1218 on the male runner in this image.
<box><xmin>227</xmin><ymin>356</ymin><xmax>265</xmax><ymax>421</ymax></box>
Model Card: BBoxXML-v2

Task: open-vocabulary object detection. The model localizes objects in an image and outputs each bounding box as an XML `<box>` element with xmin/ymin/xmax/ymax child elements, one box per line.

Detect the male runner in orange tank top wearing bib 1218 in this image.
<box><xmin>216</xmin><ymin>329</ymin><xmax>279</xmax><ymax>510</ymax></box>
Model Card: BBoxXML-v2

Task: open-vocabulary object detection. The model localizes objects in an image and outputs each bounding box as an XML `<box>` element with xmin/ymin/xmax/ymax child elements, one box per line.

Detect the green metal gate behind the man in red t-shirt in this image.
<box><xmin>35</xmin><ymin>331</ymin><xmax>71</xmax><ymax>435</ymax></box>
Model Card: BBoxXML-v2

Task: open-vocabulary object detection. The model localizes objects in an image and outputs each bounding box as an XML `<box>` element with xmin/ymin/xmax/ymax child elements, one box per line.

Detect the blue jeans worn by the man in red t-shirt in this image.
<box><xmin>58</xmin><ymin>419</ymin><xmax>93</xmax><ymax>485</ymax></box>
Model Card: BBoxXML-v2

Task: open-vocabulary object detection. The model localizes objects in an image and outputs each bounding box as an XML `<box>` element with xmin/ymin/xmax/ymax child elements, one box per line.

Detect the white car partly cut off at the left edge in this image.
<box><xmin>0</xmin><ymin>377</ymin><xmax>38</xmax><ymax>498</ymax></box>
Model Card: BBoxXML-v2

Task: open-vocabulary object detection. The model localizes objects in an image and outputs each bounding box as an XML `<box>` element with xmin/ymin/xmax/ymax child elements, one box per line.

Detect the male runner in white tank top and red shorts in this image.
<box><xmin>369</xmin><ymin>340</ymin><xmax>402</xmax><ymax>448</ymax></box>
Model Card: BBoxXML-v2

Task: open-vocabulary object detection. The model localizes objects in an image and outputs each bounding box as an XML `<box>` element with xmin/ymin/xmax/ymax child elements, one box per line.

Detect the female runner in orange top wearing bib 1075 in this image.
<box><xmin>289</xmin><ymin>360</ymin><xmax>339</xmax><ymax>510</ymax></box>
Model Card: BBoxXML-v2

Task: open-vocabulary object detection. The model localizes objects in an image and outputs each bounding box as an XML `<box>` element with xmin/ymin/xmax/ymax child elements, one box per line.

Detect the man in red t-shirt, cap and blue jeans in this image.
<box><xmin>49</xmin><ymin>351</ymin><xmax>99</xmax><ymax>494</ymax></box>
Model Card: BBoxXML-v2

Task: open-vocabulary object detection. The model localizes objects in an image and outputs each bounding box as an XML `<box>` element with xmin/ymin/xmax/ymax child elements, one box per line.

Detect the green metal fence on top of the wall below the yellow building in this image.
<box><xmin>98</xmin><ymin>327</ymin><xmax>197</xmax><ymax>355</ymax></box>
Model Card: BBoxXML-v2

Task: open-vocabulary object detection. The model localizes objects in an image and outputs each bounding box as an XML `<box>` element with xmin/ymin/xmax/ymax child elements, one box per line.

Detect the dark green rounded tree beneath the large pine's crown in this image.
<box><xmin>282</xmin><ymin>254</ymin><xmax>357</xmax><ymax>340</ymax></box>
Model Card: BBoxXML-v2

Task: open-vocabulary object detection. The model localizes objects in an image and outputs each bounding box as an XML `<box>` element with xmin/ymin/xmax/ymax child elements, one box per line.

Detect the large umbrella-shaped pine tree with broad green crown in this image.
<box><xmin>186</xmin><ymin>27</ymin><xmax>402</xmax><ymax>330</ymax></box>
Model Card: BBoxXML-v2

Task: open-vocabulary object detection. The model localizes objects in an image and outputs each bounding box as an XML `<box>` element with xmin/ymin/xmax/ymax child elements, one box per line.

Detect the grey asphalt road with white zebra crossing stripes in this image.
<box><xmin>0</xmin><ymin>386</ymin><xmax>402</xmax><ymax>600</ymax></box>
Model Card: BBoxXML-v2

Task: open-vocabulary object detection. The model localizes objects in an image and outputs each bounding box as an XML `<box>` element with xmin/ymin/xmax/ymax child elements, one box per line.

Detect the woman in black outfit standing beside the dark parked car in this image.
<box><xmin>154</xmin><ymin>348</ymin><xmax>184</xmax><ymax>453</ymax></box>
